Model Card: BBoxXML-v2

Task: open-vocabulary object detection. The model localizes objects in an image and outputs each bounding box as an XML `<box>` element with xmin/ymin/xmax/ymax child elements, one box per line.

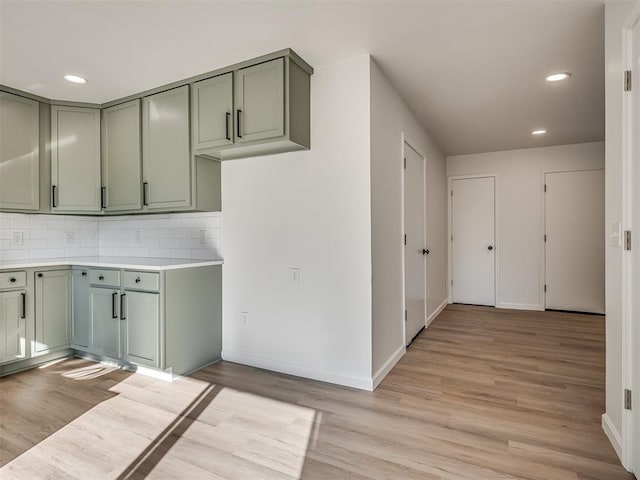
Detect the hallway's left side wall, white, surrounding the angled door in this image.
<box><xmin>371</xmin><ymin>60</ymin><xmax>448</xmax><ymax>381</ymax></box>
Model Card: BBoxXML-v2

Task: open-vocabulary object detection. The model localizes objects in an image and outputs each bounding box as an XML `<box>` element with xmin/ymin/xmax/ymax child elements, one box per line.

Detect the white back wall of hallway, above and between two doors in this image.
<box><xmin>447</xmin><ymin>142</ymin><xmax>604</xmax><ymax>309</ymax></box>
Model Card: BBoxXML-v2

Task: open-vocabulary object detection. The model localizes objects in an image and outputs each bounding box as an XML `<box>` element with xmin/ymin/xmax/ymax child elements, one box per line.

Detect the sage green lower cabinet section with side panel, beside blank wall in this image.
<box><xmin>71</xmin><ymin>265</ymin><xmax>222</xmax><ymax>375</ymax></box>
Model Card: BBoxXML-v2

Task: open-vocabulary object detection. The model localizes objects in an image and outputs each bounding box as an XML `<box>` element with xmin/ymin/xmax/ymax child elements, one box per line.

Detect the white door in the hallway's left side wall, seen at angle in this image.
<box><xmin>404</xmin><ymin>143</ymin><xmax>426</xmax><ymax>345</ymax></box>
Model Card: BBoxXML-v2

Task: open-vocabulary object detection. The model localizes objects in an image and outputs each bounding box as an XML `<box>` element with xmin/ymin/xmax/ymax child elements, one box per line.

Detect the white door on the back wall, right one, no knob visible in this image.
<box><xmin>545</xmin><ymin>170</ymin><xmax>605</xmax><ymax>313</ymax></box>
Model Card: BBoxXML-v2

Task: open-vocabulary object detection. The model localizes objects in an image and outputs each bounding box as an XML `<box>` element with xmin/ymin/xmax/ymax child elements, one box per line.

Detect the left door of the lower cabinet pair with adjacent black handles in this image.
<box><xmin>89</xmin><ymin>287</ymin><xmax>122</xmax><ymax>358</ymax></box>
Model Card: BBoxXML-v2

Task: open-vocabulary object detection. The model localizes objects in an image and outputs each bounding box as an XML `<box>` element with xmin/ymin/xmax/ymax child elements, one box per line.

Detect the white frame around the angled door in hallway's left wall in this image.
<box><xmin>398</xmin><ymin>132</ymin><xmax>429</xmax><ymax>351</ymax></box>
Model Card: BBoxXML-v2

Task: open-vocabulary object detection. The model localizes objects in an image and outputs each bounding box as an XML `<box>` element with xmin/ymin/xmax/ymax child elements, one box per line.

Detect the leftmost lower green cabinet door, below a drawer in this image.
<box><xmin>0</xmin><ymin>290</ymin><xmax>27</xmax><ymax>363</ymax></box>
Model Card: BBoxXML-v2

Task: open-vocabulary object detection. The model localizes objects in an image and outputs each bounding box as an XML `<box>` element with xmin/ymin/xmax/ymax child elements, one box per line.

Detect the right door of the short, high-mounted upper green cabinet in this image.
<box><xmin>235</xmin><ymin>58</ymin><xmax>284</xmax><ymax>143</ymax></box>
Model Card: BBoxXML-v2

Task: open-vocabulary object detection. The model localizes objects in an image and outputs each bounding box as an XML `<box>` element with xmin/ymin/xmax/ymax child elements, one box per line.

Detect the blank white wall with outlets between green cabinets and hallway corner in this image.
<box><xmin>222</xmin><ymin>55</ymin><xmax>371</xmax><ymax>388</ymax></box>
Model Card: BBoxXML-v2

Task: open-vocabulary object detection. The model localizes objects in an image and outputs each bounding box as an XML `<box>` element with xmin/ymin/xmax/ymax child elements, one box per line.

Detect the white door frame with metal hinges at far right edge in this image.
<box><xmin>620</xmin><ymin>4</ymin><xmax>640</xmax><ymax>474</ymax></box>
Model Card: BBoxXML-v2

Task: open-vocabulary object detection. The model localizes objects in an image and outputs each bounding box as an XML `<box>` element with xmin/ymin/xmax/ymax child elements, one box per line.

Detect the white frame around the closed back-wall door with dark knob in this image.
<box><xmin>446</xmin><ymin>173</ymin><xmax>500</xmax><ymax>308</ymax></box>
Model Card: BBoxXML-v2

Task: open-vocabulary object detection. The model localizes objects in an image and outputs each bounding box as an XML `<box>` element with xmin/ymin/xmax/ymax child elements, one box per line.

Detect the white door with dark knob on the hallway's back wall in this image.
<box><xmin>451</xmin><ymin>177</ymin><xmax>496</xmax><ymax>306</ymax></box>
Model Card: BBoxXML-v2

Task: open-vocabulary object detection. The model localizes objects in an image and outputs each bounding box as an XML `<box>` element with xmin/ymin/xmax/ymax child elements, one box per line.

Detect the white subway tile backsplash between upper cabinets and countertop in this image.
<box><xmin>0</xmin><ymin>212</ymin><xmax>222</xmax><ymax>260</ymax></box>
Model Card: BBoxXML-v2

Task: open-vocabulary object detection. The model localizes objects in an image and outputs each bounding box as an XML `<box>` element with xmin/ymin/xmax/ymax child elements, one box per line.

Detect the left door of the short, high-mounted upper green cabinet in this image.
<box><xmin>191</xmin><ymin>72</ymin><xmax>233</xmax><ymax>150</ymax></box>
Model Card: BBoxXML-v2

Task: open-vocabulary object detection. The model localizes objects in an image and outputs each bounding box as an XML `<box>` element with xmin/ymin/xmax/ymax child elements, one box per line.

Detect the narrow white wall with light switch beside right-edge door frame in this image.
<box><xmin>604</xmin><ymin>0</ymin><xmax>638</xmax><ymax>453</ymax></box>
